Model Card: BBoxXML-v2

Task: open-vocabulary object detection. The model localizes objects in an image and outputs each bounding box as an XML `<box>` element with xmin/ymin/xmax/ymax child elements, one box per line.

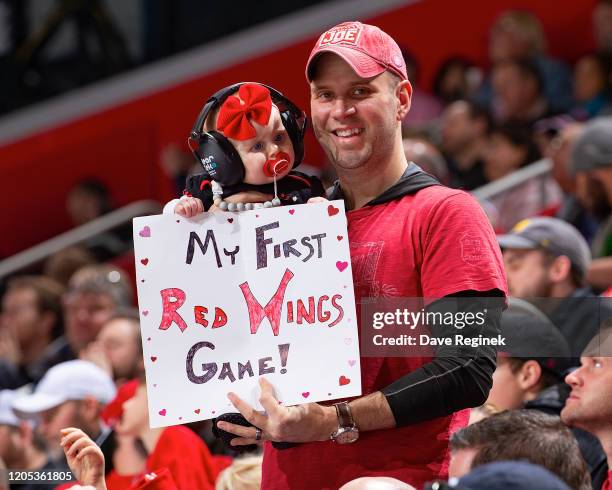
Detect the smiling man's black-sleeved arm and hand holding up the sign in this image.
<box><xmin>219</xmin><ymin>291</ymin><xmax>504</xmax><ymax>445</ymax></box>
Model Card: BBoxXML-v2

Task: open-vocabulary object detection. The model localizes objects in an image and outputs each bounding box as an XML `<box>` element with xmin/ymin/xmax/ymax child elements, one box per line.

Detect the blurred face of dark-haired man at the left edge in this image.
<box><xmin>0</xmin><ymin>288</ymin><xmax>42</xmax><ymax>349</ymax></box>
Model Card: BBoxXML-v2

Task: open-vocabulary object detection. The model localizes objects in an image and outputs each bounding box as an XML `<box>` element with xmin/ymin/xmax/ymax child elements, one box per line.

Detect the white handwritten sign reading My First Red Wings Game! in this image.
<box><xmin>134</xmin><ymin>201</ymin><xmax>361</xmax><ymax>427</ymax></box>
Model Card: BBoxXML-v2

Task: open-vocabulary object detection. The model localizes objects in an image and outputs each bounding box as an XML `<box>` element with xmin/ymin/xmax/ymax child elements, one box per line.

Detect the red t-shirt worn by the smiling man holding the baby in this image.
<box><xmin>262</xmin><ymin>186</ymin><xmax>507</xmax><ymax>490</ymax></box>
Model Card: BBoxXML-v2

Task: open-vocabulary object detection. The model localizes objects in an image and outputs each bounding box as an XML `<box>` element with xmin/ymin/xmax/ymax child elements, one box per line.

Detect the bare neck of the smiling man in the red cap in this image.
<box><xmin>337</xmin><ymin>140</ymin><xmax>408</xmax><ymax>210</ymax></box>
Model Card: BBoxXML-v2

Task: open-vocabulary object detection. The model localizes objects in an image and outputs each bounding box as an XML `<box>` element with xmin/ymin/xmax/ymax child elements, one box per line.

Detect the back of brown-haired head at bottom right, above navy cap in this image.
<box><xmin>449</xmin><ymin>410</ymin><xmax>591</xmax><ymax>490</ymax></box>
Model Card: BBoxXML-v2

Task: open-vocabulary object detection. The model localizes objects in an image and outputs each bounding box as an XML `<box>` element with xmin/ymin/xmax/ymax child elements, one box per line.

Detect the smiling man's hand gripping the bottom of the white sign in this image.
<box><xmin>219</xmin><ymin>378</ymin><xmax>338</xmax><ymax>446</ymax></box>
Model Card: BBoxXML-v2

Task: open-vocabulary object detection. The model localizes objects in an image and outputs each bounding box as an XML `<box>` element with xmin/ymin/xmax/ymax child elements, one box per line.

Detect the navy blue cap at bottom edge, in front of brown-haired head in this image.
<box><xmin>425</xmin><ymin>461</ymin><xmax>575</xmax><ymax>490</ymax></box>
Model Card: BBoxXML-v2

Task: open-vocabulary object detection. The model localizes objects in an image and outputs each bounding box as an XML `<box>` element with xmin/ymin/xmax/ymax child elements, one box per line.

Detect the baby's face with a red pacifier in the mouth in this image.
<box><xmin>228</xmin><ymin>105</ymin><xmax>295</xmax><ymax>185</ymax></box>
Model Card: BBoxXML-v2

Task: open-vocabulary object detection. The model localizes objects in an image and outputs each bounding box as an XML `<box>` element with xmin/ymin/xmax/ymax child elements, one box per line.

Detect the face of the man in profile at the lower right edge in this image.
<box><xmin>561</xmin><ymin>354</ymin><xmax>612</xmax><ymax>433</ymax></box>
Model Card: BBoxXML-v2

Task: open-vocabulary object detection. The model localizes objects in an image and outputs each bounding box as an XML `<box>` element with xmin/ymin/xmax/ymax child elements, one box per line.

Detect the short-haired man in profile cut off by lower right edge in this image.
<box><xmin>561</xmin><ymin>319</ymin><xmax>612</xmax><ymax>490</ymax></box>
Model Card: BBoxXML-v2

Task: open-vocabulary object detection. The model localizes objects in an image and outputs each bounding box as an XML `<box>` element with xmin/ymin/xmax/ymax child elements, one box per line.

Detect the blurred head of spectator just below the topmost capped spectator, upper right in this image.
<box><xmin>491</xmin><ymin>60</ymin><xmax>552</xmax><ymax>126</ymax></box>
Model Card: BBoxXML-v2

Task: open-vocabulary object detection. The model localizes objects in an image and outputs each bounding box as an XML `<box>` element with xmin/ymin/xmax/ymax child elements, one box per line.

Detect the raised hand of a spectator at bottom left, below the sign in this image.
<box><xmin>61</xmin><ymin>427</ymin><xmax>106</xmax><ymax>490</ymax></box>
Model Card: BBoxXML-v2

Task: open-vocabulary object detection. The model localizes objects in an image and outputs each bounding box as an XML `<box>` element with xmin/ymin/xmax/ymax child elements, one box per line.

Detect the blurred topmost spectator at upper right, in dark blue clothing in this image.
<box><xmin>478</xmin><ymin>10</ymin><xmax>572</xmax><ymax>112</ymax></box>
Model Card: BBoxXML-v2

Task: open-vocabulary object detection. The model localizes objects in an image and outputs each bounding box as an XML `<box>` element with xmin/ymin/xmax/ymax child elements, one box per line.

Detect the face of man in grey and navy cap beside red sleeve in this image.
<box><xmin>503</xmin><ymin>248</ymin><xmax>553</xmax><ymax>298</ymax></box>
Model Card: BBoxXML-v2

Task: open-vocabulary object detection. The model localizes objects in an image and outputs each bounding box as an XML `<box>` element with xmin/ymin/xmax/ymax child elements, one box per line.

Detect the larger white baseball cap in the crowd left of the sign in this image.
<box><xmin>13</xmin><ymin>360</ymin><xmax>117</xmax><ymax>416</ymax></box>
